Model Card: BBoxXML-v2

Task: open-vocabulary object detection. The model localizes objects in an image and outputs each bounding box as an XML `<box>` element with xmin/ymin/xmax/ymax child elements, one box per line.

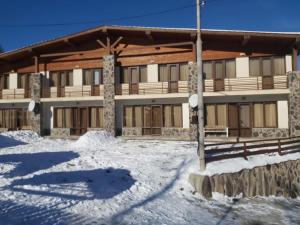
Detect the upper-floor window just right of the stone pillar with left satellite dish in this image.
<box><xmin>50</xmin><ymin>70</ymin><xmax>73</xmax><ymax>87</ymax></box>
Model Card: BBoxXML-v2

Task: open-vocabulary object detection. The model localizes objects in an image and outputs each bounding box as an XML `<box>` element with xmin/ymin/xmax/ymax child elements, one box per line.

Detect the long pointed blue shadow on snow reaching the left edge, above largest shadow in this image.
<box><xmin>0</xmin><ymin>151</ymin><xmax>79</xmax><ymax>178</ymax></box>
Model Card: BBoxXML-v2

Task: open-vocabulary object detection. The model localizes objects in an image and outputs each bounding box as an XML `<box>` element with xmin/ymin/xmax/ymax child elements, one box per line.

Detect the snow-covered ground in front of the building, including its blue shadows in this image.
<box><xmin>0</xmin><ymin>132</ymin><xmax>300</xmax><ymax>225</ymax></box>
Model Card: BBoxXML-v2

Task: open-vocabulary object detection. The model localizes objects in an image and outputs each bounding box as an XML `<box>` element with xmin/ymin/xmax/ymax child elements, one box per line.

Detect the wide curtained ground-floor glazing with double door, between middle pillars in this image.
<box><xmin>123</xmin><ymin>104</ymin><xmax>183</xmax><ymax>129</ymax></box>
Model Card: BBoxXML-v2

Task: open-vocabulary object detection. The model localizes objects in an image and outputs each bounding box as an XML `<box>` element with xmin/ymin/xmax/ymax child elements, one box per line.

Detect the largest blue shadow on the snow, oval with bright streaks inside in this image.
<box><xmin>9</xmin><ymin>168</ymin><xmax>135</xmax><ymax>200</ymax></box>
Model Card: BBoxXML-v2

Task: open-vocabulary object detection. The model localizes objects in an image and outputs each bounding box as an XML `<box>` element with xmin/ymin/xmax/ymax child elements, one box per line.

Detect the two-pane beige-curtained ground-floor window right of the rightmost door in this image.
<box><xmin>253</xmin><ymin>102</ymin><xmax>277</xmax><ymax>128</ymax></box>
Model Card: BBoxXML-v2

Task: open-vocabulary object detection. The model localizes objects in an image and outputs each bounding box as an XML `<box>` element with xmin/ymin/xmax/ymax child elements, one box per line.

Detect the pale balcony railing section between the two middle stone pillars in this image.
<box><xmin>116</xmin><ymin>81</ymin><xmax>188</xmax><ymax>95</ymax></box>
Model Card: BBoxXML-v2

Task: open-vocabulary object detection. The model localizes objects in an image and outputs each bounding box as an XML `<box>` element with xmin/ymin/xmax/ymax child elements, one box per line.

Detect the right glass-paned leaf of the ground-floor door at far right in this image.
<box><xmin>239</xmin><ymin>104</ymin><xmax>252</xmax><ymax>137</ymax></box>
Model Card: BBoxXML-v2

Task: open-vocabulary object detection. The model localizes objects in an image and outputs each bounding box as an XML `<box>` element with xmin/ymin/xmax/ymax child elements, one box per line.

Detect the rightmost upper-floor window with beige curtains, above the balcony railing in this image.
<box><xmin>249</xmin><ymin>56</ymin><xmax>286</xmax><ymax>77</ymax></box>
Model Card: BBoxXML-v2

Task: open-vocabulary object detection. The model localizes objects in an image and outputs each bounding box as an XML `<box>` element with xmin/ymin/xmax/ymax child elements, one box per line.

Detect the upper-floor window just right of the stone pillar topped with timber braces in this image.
<box><xmin>121</xmin><ymin>66</ymin><xmax>147</xmax><ymax>84</ymax></box>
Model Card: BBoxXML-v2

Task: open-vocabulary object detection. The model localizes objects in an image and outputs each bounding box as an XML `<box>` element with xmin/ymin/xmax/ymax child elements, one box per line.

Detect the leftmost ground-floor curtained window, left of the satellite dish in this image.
<box><xmin>0</xmin><ymin>109</ymin><xmax>29</xmax><ymax>130</ymax></box>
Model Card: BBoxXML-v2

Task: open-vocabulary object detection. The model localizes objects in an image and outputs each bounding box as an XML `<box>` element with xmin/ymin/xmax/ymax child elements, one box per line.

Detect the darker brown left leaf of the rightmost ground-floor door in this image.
<box><xmin>228</xmin><ymin>104</ymin><xmax>239</xmax><ymax>137</ymax></box>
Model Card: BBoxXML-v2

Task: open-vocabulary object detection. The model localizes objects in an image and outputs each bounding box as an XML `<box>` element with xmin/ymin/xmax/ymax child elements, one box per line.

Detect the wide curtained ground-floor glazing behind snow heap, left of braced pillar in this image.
<box><xmin>54</xmin><ymin>107</ymin><xmax>103</xmax><ymax>129</ymax></box>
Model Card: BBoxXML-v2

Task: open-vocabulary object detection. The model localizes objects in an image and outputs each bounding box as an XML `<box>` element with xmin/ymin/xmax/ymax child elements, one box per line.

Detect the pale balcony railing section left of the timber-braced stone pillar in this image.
<box><xmin>42</xmin><ymin>85</ymin><xmax>104</xmax><ymax>98</ymax></box>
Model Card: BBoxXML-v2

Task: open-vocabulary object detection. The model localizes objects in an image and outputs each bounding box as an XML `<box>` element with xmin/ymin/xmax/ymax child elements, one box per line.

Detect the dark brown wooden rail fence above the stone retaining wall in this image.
<box><xmin>205</xmin><ymin>136</ymin><xmax>300</xmax><ymax>163</ymax></box>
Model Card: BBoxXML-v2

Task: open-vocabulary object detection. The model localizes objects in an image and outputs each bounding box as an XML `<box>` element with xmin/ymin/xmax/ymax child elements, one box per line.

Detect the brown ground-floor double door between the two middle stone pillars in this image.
<box><xmin>143</xmin><ymin>106</ymin><xmax>162</xmax><ymax>135</ymax></box>
